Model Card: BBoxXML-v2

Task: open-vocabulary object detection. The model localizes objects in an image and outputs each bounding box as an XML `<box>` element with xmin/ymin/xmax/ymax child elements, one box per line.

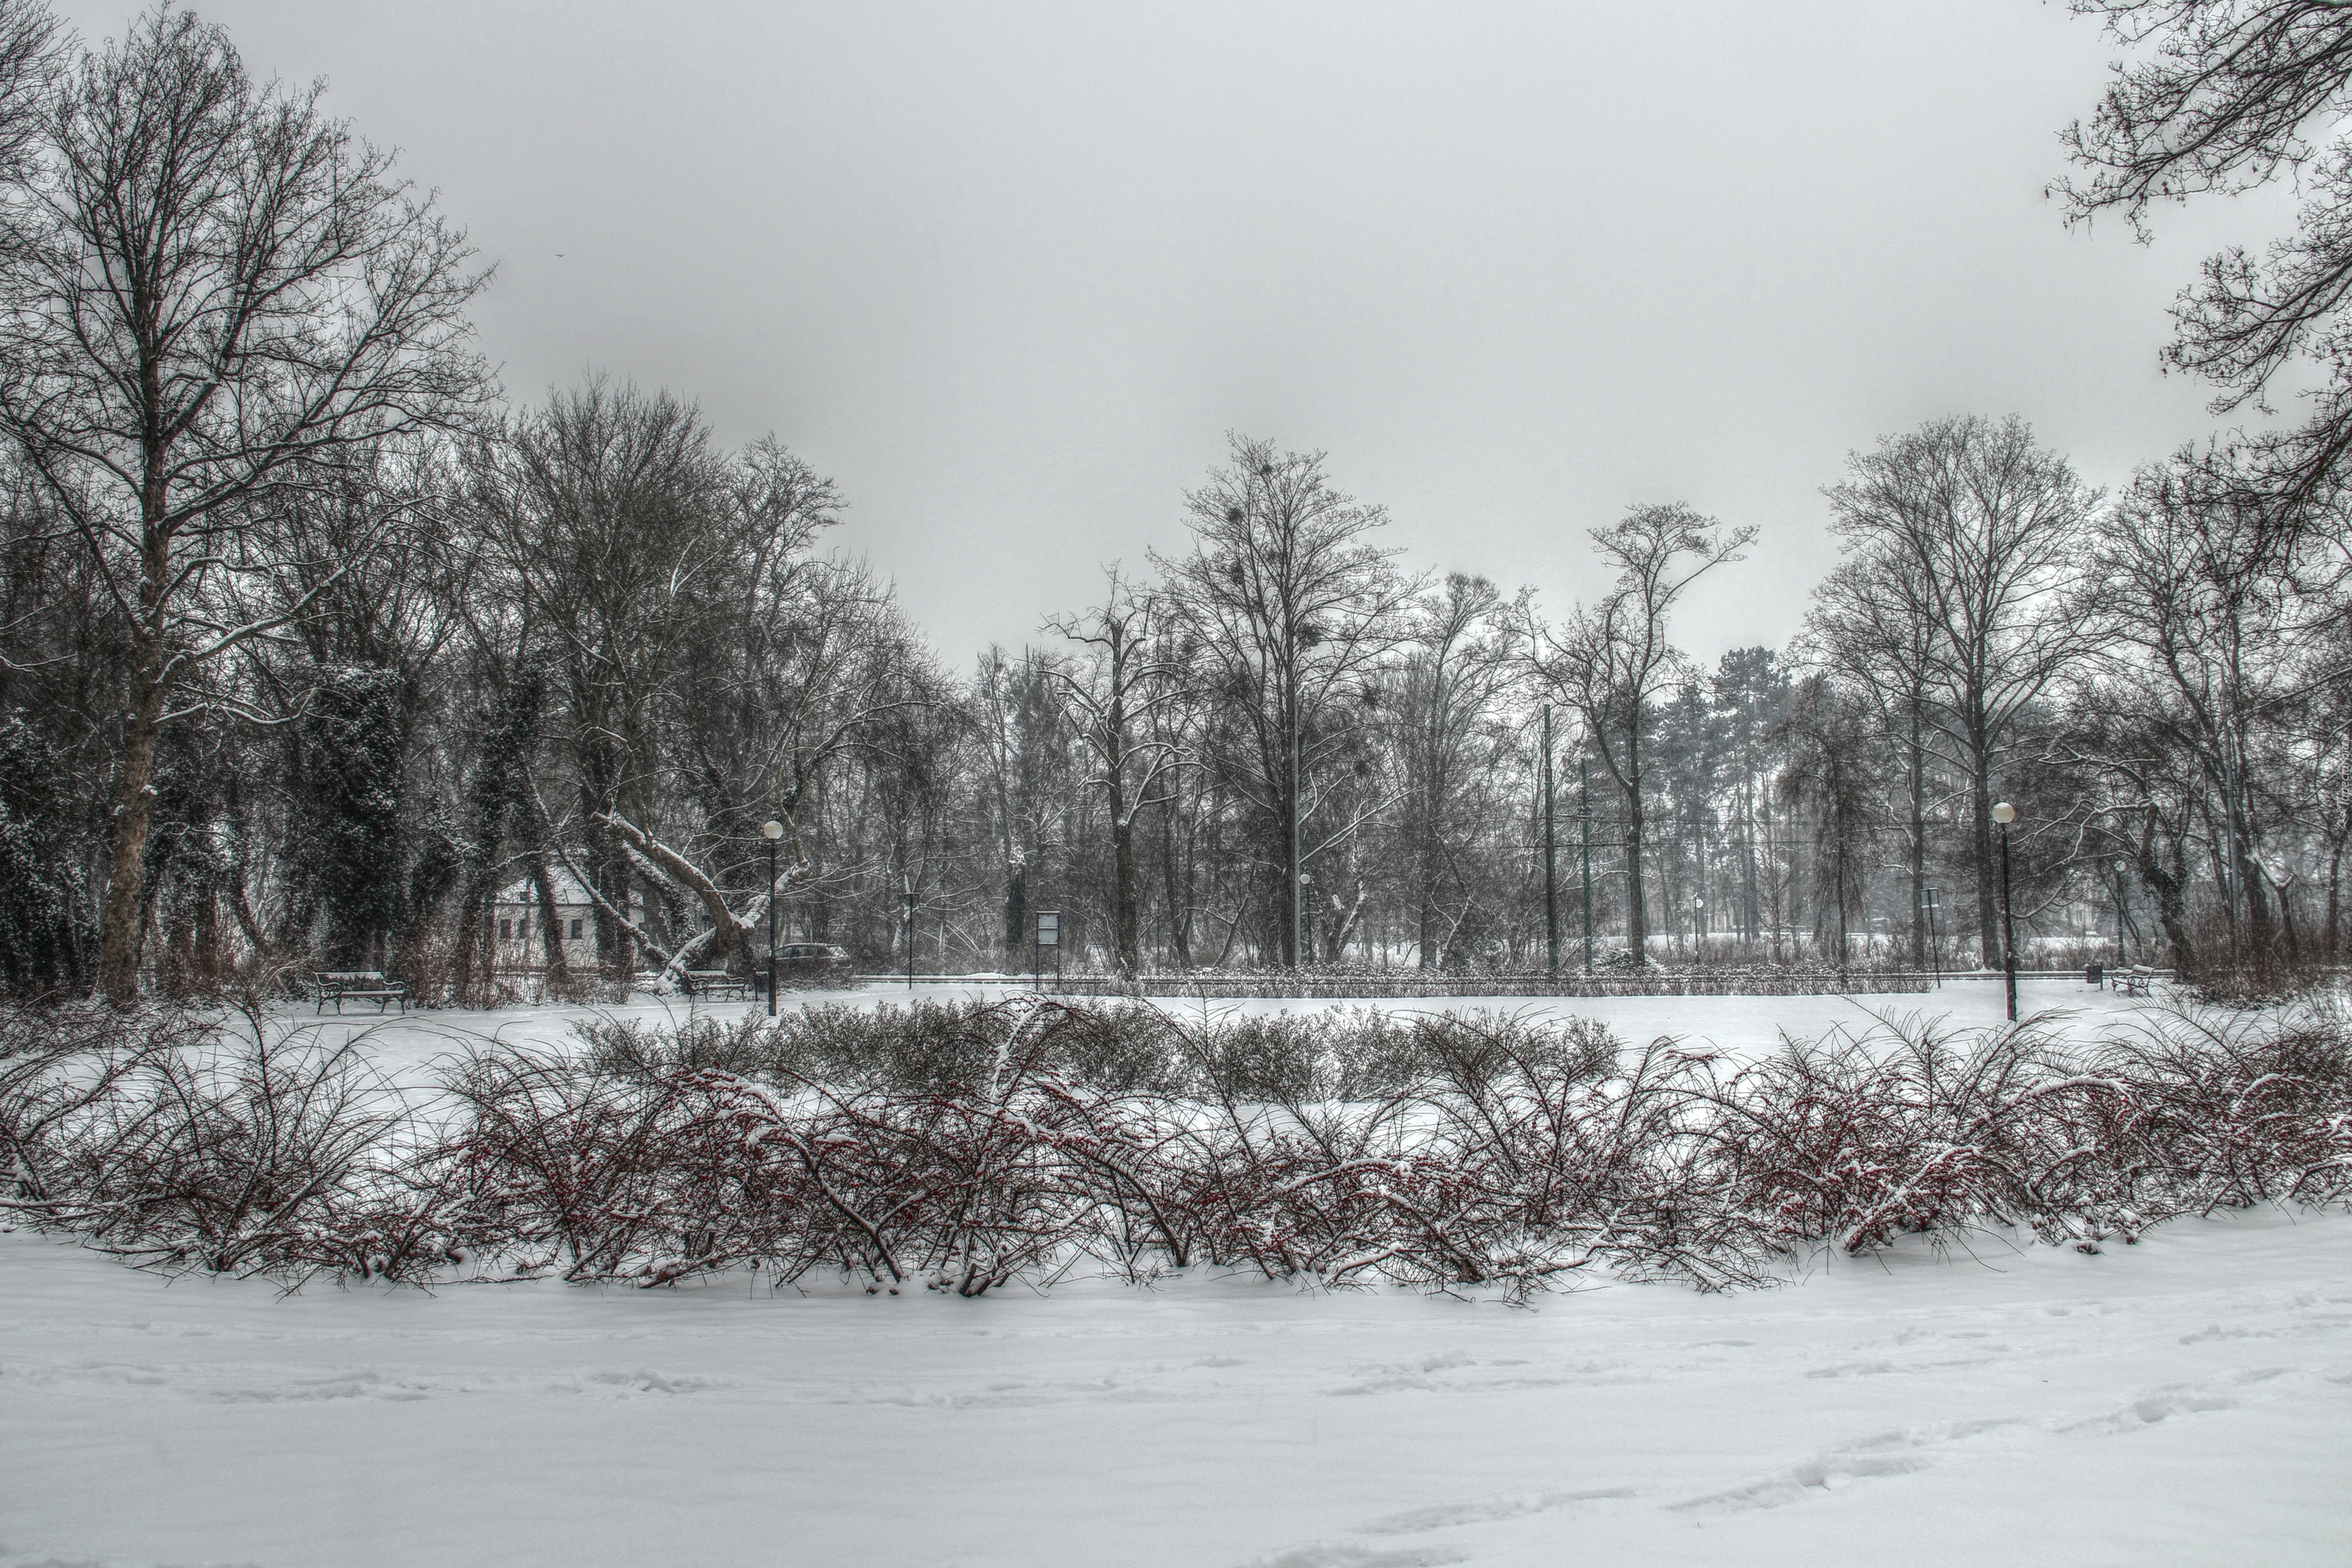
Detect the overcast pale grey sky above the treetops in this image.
<box><xmin>50</xmin><ymin>0</ymin><xmax>2284</xmax><ymax>668</ymax></box>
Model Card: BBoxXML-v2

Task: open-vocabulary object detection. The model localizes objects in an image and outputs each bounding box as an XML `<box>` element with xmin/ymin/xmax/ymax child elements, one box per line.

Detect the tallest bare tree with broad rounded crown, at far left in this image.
<box><xmin>0</xmin><ymin>9</ymin><xmax>484</xmax><ymax>1001</ymax></box>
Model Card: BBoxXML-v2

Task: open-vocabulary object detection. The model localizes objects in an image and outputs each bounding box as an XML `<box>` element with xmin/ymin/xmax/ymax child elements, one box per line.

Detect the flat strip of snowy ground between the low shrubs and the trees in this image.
<box><xmin>308</xmin><ymin>976</ymin><xmax>2162</xmax><ymax>1079</ymax></box>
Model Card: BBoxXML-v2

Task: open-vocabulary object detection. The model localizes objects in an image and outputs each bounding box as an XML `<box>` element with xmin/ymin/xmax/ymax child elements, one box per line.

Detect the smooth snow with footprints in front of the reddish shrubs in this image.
<box><xmin>0</xmin><ymin>1213</ymin><xmax>2352</xmax><ymax>1568</ymax></box>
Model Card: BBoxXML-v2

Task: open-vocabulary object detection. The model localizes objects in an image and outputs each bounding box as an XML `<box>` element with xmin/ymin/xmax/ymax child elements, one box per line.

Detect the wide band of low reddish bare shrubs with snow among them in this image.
<box><xmin>0</xmin><ymin>997</ymin><xmax>2352</xmax><ymax>1295</ymax></box>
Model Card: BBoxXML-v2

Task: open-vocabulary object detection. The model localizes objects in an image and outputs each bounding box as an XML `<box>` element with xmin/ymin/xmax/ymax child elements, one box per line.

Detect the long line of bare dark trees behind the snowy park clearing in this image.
<box><xmin>0</xmin><ymin>0</ymin><xmax>2352</xmax><ymax>1001</ymax></box>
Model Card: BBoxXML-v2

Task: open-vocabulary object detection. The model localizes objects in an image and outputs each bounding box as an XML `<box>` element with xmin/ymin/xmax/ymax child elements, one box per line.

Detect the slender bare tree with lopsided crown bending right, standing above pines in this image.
<box><xmin>1529</xmin><ymin>501</ymin><xmax>1757</xmax><ymax>964</ymax></box>
